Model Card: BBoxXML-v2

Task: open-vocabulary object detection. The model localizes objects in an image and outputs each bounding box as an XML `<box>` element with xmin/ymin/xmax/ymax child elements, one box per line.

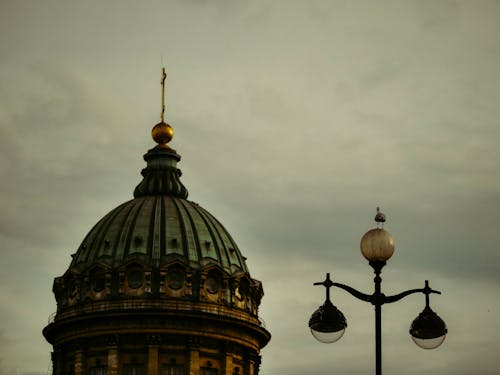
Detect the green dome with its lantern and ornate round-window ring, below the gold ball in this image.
<box><xmin>47</xmin><ymin>144</ymin><xmax>263</xmax><ymax>324</ymax></box>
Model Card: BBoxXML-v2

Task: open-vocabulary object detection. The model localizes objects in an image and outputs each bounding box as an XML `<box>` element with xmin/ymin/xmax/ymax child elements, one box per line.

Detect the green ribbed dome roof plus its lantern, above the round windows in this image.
<box><xmin>69</xmin><ymin>146</ymin><xmax>248</xmax><ymax>275</ymax></box>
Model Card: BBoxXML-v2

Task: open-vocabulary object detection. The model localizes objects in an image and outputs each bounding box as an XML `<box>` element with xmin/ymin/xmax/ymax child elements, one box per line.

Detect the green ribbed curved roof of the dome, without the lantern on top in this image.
<box><xmin>70</xmin><ymin>195</ymin><xmax>247</xmax><ymax>274</ymax></box>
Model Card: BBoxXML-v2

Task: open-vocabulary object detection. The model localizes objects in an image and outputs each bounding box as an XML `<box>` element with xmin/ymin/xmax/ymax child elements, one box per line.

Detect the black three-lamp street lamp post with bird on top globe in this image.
<box><xmin>309</xmin><ymin>207</ymin><xmax>448</xmax><ymax>375</ymax></box>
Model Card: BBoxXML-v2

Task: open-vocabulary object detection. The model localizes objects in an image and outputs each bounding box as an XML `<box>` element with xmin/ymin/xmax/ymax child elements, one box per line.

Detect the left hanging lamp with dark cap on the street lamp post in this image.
<box><xmin>309</xmin><ymin>300</ymin><xmax>347</xmax><ymax>344</ymax></box>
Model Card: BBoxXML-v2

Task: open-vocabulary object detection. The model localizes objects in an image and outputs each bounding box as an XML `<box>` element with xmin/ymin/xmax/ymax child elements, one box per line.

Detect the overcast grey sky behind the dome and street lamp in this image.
<box><xmin>0</xmin><ymin>0</ymin><xmax>500</xmax><ymax>375</ymax></box>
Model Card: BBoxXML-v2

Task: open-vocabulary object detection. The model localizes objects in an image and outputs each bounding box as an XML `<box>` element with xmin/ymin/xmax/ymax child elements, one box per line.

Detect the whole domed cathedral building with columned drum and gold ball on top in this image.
<box><xmin>43</xmin><ymin>78</ymin><xmax>271</xmax><ymax>375</ymax></box>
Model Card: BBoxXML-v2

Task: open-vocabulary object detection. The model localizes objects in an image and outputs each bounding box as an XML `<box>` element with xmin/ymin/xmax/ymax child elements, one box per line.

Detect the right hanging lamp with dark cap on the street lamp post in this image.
<box><xmin>410</xmin><ymin>306</ymin><xmax>448</xmax><ymax>349</ymax></box>
